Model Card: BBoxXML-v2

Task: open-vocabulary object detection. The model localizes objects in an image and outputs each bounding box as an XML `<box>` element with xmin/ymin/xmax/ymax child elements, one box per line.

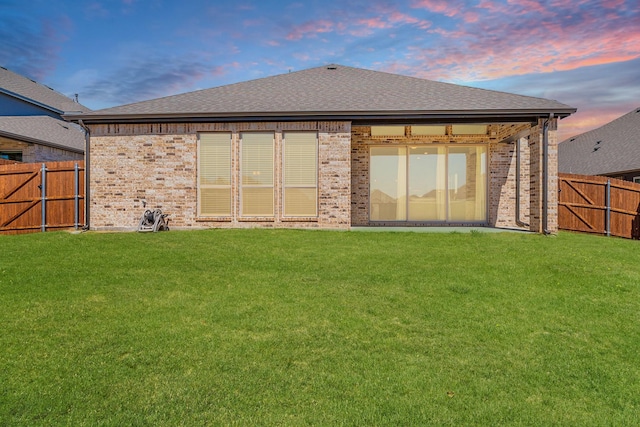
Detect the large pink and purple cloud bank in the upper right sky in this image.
<box><xmin>409</xmin><ymin>0</ymin><xmax>640</xmax><ymax>81</ymax></box>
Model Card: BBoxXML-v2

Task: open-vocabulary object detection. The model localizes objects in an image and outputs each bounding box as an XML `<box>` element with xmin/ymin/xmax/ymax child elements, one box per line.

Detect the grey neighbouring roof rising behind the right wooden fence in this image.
<box><xmin>558</xmin><ymin>108</ymin><xmax>640</xmax><ymax>175</ymax></box>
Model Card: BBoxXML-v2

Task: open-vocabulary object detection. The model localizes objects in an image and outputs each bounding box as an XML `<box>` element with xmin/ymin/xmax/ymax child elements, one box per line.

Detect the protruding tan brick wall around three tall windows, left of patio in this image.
<box><xmin>89</xmin><ymin>122</ymin><xmax>351</xmax><ymax>230</ymax></box>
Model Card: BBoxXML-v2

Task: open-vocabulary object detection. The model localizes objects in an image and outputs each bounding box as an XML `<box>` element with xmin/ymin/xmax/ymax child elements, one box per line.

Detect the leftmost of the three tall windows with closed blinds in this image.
<box><xmin>198</xmin><ymin>133</ymin><xmax>232</xmax><ymax>216</ymax></box>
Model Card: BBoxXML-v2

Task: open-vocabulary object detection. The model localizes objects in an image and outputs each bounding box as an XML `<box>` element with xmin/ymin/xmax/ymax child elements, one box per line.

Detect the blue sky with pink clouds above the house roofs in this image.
<box><xmin>0</xmin><ymin>0</ymin><xmax>640</xmax><ymax>140</ymax></box>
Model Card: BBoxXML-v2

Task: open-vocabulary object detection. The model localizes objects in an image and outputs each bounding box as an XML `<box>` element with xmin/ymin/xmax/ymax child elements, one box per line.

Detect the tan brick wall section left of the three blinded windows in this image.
<box><xmin>90</xmin><ymin>135</ymin><xmax>196</xmax><ymax>229</ymax></box>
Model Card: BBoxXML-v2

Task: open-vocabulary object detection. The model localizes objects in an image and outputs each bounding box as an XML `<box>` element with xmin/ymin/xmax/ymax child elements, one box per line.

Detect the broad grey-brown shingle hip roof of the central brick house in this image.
<box><xmin>67</xmin><ymin>65</ymin><xmax>576</xmax><ymax>123</ymax></box>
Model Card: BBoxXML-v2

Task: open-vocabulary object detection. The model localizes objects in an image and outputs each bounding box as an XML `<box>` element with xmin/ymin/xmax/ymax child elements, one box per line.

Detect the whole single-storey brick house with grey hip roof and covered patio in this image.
<box><xmin>67</xmin><ymin>64</ymin><xmax>575</xmax><ymax>233</ymax></box>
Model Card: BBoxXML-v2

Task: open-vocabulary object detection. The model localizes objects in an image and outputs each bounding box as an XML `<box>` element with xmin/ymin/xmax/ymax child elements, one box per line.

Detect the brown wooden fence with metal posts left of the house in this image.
<box><xmin>0</xmin><ymin>161</ymin><xmax>85</xmax><ymax>234</ymax></box>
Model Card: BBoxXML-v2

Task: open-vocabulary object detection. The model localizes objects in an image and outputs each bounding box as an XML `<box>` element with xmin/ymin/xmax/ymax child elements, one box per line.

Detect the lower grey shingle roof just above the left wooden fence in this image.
<box><xmin>0</xmin><ymin>116</ymin><xmax>85</xmax><ymax>153</ymax></box>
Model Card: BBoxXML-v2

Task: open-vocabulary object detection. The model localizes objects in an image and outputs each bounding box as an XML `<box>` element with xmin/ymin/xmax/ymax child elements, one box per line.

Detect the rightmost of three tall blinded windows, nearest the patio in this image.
<box><xmin>283</xmin><ymin>132</ymin><xmax>318</xmax><ymax>217</ymax></box>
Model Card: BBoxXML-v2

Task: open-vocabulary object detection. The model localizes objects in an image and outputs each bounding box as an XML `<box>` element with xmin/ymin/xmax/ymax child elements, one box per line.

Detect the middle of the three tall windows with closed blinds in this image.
<box><xmin>240</xmin><ymin>132</ymin><xmax>274</xmax><ymax>217</ymax></box>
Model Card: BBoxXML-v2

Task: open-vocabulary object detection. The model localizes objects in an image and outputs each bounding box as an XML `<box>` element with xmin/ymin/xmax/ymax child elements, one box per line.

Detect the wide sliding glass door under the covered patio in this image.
<box><xmin>369</xmin><ymin>146</ymin><xmax>487</xmax><ymax>222</ymax></box>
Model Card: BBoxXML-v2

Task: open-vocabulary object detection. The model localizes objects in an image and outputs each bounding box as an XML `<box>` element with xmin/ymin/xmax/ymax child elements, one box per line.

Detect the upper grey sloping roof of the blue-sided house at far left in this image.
<box><xmin>0</xmin><ymin>67</ymin><xmax>91</xmax><ymax>114</ymax></box>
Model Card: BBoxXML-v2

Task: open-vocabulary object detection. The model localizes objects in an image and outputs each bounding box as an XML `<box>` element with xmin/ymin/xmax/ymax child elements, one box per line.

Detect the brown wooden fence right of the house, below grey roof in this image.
<box><xmin>558</xmin><ymin>173</ymin><xmax>640</xmax><ymax>239</ymax></box>
